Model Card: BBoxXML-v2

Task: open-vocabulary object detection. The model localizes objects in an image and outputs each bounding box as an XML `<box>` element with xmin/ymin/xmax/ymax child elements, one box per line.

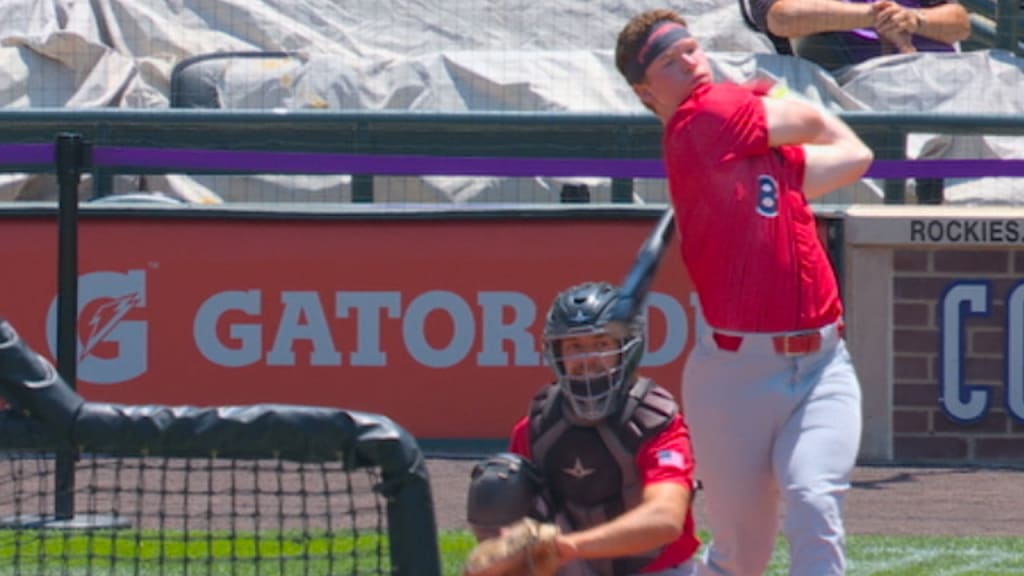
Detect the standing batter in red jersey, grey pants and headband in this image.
<box><xmin>615</xmin><ymin>10</ymin><xmax>872</xmax><ymax>576</ymax></box>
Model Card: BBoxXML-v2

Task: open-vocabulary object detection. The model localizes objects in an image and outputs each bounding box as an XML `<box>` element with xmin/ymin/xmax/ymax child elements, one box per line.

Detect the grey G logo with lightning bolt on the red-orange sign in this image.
<box><xmin>46</xmin><ymin>270</ymin><xmax>148</xmax><ymax>384</ymax></box>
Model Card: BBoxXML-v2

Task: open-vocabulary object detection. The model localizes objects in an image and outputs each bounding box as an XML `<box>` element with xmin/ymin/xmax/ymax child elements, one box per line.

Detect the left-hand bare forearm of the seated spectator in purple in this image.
<box><xmin>766</xmin><ymin>0</ymin><xmax>874</xmax><ymax>38</ymax></box>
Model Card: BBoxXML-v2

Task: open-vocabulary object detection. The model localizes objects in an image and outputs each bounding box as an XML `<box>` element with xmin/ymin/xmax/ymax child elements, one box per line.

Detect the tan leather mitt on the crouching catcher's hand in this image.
<box><xmin>465</xmin><ymin>518</ymin><xmax>561</xmax><ymax>576</ymax></box>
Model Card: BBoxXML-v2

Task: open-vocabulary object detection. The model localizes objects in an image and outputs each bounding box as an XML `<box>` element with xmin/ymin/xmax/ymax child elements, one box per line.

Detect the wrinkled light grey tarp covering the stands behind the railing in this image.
<box><xmin>0</xmin><ymin>0</ymin><xmax>1024</xmax><ymax>202</ymax></box>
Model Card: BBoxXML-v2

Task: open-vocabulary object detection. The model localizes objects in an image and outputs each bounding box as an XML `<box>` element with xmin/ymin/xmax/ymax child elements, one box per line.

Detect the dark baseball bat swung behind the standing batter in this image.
<box><xmin>605</xmin><ymin>206</ymin><xmax>676</xmax><ymax>339</ymax></box>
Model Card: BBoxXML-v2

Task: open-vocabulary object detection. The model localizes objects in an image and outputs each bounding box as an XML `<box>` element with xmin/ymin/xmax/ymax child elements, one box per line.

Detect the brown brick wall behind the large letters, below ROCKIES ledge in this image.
<box><xmin>892</xmin><ymin>249</ymin><xmax>1024</xmax><ymax>463</ymax></box>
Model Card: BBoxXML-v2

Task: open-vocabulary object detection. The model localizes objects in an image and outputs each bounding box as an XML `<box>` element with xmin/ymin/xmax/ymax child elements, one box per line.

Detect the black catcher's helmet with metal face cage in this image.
<box><xmin>544</xmin><ymin>282</ymin><xmax>644</xmax><ymax>424</ymax></box>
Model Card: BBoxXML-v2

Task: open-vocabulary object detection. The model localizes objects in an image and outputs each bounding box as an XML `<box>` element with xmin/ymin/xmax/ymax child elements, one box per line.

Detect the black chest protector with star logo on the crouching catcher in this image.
<box><xmin>529</xmin><ymin>378</ymin><xmax>678</xmax><ymax>576</ymax></box>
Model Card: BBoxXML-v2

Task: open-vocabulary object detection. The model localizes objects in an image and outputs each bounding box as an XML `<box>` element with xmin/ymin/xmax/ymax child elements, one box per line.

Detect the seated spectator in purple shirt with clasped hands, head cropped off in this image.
<box><xmin>741</xmin><ymin>0</ymin><xmax>971</xmax><ymax>72</ymax></box>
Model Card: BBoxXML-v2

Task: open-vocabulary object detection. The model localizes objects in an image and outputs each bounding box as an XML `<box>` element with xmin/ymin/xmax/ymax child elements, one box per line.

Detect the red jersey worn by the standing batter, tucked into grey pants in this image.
<box><xmin>663</xmin><ymin>83</ymin><xmax>843</xmax><ymax>332</ymax></box>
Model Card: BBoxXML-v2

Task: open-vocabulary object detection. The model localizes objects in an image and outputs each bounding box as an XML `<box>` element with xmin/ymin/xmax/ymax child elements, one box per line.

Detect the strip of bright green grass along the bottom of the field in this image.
<box><xmin>0</xmin><ymin>530</ymin><xmax>1024</xmax><ymax>576</ymax></box>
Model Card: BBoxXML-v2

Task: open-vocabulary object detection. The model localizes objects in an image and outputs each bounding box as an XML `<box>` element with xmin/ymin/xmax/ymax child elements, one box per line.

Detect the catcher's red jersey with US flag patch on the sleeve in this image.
<box><xmin>509</xmin><ymin>414</ymin><xmax>700</xmax><ymax>573</ymax></box>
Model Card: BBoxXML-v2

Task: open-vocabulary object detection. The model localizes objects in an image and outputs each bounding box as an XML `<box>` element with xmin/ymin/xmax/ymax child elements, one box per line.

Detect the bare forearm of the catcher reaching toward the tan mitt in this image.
<box><xmin>557</xmin><ymin>482</ymin><xmax>690</xmax><ymax>562</ymax></box>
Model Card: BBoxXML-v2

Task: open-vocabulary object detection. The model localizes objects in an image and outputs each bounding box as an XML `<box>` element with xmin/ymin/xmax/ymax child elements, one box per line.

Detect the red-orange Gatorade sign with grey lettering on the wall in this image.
<box><xmin>0</xmin><ymin>216</ymin><xmax>815</xmax><ymax>438</ymax></box>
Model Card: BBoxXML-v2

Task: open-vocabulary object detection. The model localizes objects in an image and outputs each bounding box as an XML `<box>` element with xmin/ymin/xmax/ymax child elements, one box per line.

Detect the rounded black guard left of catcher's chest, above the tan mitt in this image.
<box><xmin>466</xmin><ymin>452</ymin><xmax>550</xmax><ymax>540</ymax></box>
